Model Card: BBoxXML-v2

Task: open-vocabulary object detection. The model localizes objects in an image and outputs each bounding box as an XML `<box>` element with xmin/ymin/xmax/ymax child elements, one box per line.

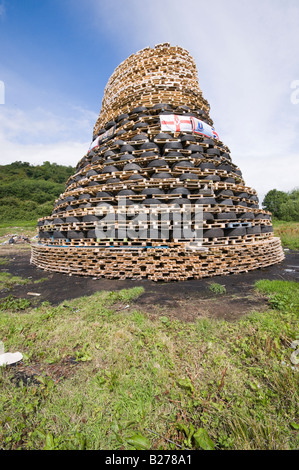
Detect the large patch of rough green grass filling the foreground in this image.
<box><xmin>0</xmin><ymin>281</ymin><xmax>299</xmax><ymax>450</ymax></box>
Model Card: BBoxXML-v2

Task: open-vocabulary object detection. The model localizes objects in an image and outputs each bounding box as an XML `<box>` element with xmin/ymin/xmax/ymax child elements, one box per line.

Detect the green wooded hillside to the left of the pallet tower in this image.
<box><xmin>0</xmin><ymin>162</ymin><xmax>75</xmax><ymax>223</ymax></box>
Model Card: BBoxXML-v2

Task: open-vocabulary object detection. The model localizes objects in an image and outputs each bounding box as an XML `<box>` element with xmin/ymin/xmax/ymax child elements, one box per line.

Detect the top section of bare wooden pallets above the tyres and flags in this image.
<box><xmin>95</xmin><ymin>43</ymin><xmax>210</xmax><ymax>131</ymax></box>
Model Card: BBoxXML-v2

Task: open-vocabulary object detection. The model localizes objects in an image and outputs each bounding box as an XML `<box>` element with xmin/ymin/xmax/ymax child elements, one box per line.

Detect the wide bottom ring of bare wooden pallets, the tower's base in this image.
<box><xmin>31</xmin><ymin>237</ymin><xmax>284</xmax><ymax>282</ymax></box>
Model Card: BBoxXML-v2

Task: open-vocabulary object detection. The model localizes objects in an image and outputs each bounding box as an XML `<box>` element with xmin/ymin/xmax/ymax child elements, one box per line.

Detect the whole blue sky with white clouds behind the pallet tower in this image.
<box><xmin>0</xmin><ymin>0</ymin><xmax>299</xmax><ymax>198</ymax></box>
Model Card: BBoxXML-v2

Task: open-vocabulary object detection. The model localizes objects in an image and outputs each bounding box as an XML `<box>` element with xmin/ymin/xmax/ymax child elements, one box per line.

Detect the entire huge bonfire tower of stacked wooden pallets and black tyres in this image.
<box><xmin>31</xmin><ymin>44</ymin><xmax>284</xmax><ymax>281</ymax></box>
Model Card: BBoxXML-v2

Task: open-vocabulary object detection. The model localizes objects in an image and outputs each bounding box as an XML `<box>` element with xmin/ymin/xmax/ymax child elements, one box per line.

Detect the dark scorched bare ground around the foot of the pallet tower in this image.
<box><xmin>0</xmin><ymin>245</ymin><xmax>299</xmax><ymax>321</ymax></box>
